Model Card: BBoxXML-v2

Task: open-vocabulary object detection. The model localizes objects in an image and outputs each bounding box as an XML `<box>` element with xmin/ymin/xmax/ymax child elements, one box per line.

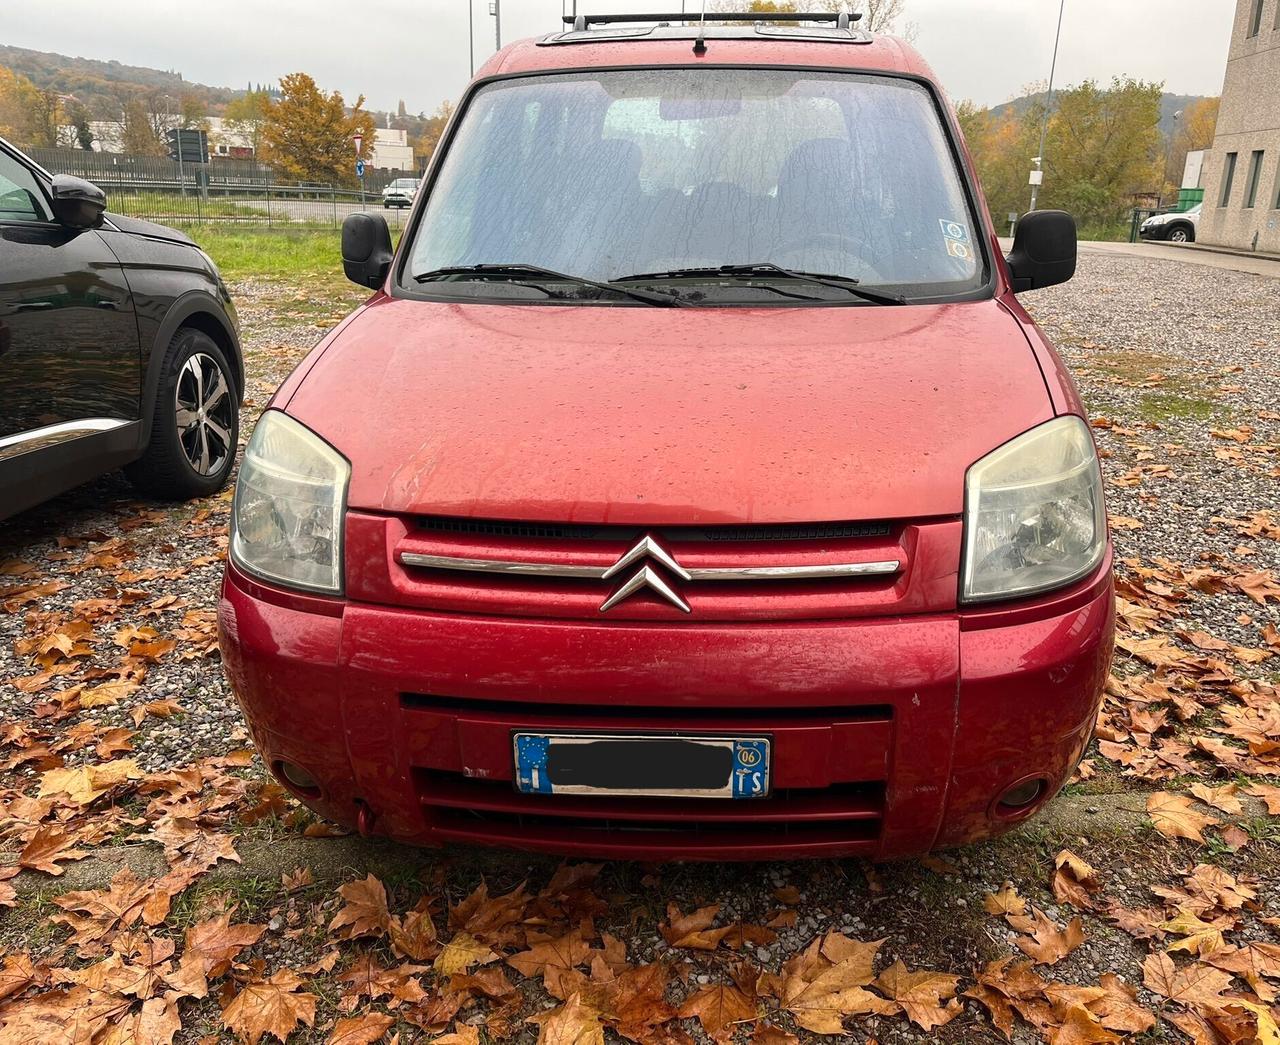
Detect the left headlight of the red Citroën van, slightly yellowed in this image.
<box><xmin>230</xmin><ymin>410</ymin><xmax>351</xmax><ymax>594</ymax></box>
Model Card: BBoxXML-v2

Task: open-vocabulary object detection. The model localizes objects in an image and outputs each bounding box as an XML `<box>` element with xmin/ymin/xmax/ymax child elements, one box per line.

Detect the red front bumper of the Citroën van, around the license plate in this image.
<box><xmin>219</xmin><ymin>555</ymin><xmax>1115</xmax><ymax>859</ymax></box>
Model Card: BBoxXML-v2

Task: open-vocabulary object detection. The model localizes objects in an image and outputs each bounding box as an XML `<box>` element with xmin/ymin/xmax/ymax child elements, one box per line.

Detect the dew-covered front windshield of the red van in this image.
<box><xmin>404</xmin><ymin>68</ymin><xmax>986</xmax><ymax>305</ymax></box>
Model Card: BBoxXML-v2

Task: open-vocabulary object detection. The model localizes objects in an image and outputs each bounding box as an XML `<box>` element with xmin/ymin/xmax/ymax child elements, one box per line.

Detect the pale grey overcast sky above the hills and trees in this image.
<box><xmin>4</xmin><ymin>0</ymin><xmax>1235</xmax><ymax>111</ymax></box>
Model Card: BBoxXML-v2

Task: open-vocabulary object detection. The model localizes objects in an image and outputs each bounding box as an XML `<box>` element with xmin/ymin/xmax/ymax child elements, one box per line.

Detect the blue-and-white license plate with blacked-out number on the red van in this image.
<box><xmin>512</xmin><ymin>733</ymin><xmax>771</xmax><ymax>798</ymax></box>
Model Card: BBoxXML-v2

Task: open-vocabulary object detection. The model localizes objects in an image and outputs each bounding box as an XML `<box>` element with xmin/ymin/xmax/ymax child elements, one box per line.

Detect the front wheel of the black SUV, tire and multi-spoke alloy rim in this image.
<box><xmin>124</xmin><ymin>327</ymin><xmax>239</xmax><ymax>501</ymax></box>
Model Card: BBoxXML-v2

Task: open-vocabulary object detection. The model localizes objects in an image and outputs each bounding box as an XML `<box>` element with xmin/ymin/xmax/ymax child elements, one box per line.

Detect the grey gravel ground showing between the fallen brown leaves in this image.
<box><xmin>0</xmin><ymin>254</ymin><xmax>1280</xmax><ymax>1042</ymax></box>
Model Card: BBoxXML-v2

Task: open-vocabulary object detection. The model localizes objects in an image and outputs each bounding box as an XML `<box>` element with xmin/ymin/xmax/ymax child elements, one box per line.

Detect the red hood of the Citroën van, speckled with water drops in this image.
<box><xmin>288</xmin><ymin>296</ymin><xmax>1053</xmax><ymax>525</ymax></box>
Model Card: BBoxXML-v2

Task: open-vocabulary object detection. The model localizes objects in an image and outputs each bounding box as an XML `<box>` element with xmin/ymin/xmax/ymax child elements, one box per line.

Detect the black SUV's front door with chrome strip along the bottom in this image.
<box><xmin>0</xmin><ymin>146</ymin><xmax>142</xmax><ymax>448</ymax></box>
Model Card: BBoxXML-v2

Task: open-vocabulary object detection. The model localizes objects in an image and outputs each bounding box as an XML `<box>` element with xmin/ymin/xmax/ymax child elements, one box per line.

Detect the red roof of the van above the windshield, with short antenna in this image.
<box><xmin>476</xmin><ymin>18</ymin><xmax>936</xmax><ymax>82</ymax></box>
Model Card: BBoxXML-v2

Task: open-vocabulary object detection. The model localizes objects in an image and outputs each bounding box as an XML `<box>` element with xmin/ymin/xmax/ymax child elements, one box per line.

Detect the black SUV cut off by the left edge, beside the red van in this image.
<box><xmin>0</xmin><ymin>140</ymin><xmax>244</xmax><ymax>519</ymax></box>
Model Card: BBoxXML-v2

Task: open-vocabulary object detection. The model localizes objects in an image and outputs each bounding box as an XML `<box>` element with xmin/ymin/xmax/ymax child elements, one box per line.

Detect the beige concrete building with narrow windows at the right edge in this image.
<box><xmin>1197</xmin><ymin>0</ymin><xmax>1280</xmax><ymax>252</ymax></box>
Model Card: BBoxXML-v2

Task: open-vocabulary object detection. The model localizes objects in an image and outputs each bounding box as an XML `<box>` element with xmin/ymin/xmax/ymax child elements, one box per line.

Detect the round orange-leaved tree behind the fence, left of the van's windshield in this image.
<box><xmin>262</xmin><ymin>73</ymin><xmax>375</xmax><ymax>184</ymax></box>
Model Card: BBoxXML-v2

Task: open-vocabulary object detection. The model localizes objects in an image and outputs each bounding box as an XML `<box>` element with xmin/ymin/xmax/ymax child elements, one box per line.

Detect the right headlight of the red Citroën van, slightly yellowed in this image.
<box><xmin>961</xmin><ymin>416</ymin><xmax>1107</xmax><ymax>602</ymax></box>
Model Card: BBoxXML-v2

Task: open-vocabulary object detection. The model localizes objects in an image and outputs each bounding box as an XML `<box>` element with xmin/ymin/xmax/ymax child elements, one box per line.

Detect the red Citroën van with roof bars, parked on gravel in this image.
<box><xmin>219</xmin><ymin>15</ymin><xmax>1114</xmax><ymax>859</ymax></box>
